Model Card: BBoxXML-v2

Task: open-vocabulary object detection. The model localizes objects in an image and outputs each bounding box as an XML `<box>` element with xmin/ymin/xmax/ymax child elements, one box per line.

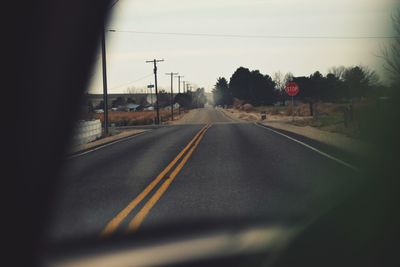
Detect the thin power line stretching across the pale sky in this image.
<box><xmin>109</xmin><ymin>29</ymin><xmax>400</xmax><ymax>40</ymax></box>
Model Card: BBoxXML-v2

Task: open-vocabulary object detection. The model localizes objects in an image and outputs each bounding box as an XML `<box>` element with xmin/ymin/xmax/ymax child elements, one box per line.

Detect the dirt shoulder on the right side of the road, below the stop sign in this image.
<box><xmin>221</xmin><ymin>109</ymin><xmax>370</xmax><ymax>155</ymax></box>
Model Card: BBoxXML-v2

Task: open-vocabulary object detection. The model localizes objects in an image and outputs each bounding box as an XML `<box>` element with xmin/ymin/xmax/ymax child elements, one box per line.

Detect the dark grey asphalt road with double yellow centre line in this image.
<box><xmin>48</xmin><ymin>108</ymin><xmax>355</xmax><ymax>245</ymax></box>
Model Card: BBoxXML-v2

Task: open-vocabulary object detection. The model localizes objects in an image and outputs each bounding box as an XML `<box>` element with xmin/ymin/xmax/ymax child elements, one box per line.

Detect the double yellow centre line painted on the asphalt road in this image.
<box><xmin>101</xmin><ymin>124</ymin><xmax>211</xmax><ymax>237</ymax></box>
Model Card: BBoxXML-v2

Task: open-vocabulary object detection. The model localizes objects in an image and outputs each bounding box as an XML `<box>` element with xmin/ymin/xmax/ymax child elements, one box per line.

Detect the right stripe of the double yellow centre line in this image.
<box><xmin>128</xmin><ymin>126</ymin><xmax>211</xmax><ymax>232</ymax></box>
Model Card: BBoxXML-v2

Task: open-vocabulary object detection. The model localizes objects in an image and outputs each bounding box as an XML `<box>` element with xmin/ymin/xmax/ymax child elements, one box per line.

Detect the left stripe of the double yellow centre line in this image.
<box><xmin>101</xmin><ymin>125</ymin><xmax>208</xmax><ymax>237</ymax></box>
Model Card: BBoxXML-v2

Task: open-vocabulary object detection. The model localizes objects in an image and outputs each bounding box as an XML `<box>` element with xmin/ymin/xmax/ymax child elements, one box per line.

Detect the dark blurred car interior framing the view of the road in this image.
<box><xmin>2</xmin><ymin>0</ymin><xmax>400</xmax><ymax>267</ymax></box>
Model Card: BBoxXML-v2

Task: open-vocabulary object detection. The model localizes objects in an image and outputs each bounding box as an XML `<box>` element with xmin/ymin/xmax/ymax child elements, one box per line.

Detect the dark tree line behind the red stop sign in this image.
<box><xmin>213</xmin><ymin>66</ymin><xmax>387</xmax><ymax>106</ymax></box>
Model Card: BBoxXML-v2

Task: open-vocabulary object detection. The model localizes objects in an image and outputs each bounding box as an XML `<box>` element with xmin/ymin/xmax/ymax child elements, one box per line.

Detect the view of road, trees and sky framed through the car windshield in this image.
<box><xmin>47</xmin><ymin>0</ymin><xmax>400</xmax><ymax>264</ymax></box>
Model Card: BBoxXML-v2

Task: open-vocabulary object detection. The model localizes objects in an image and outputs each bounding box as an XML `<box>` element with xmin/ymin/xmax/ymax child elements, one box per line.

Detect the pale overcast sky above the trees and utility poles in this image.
<box><xmin>89</xmin><ymin>0</ymin><xmax>400</xmax><ymax>93</ymax></box>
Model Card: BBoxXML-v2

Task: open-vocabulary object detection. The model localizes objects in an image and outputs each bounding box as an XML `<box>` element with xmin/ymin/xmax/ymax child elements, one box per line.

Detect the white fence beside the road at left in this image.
<box><xmin>73</xmin><ymin>120</ymin><xmax>102</xmax><ymax>145</ymax></box>
